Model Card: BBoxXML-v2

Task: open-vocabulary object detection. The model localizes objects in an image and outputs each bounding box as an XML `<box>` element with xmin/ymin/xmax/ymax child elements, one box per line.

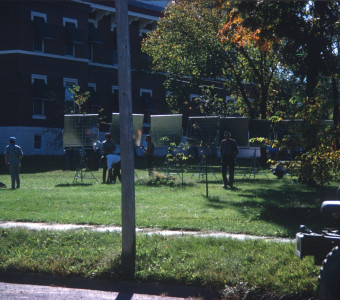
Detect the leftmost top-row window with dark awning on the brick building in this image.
<box><xmin>31</xmin><ymin>11</ymin><xmax>52</xmax><ymax>52</ymax></box>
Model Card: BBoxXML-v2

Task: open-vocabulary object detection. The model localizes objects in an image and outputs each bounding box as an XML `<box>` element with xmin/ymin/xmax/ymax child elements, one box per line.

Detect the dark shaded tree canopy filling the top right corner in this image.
<box><xmin>234</xmin><ymin>0</ymin><xmax>340</xmax><ymax>124</ymax></box>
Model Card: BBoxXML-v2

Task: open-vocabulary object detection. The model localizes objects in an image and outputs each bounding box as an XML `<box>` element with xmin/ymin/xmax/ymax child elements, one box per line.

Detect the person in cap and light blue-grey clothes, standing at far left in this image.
<box><xmin>5</xmin><ymin>137</ymin><xmax>24</xmax><ymax>190</ymax></box>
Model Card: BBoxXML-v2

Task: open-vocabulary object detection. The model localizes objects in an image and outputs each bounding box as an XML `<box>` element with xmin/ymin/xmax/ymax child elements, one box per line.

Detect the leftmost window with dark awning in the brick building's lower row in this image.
<box><xmin>31</xmin><ymin>74</ymin><xmax>48</xmax><ymax>119</ymax></box>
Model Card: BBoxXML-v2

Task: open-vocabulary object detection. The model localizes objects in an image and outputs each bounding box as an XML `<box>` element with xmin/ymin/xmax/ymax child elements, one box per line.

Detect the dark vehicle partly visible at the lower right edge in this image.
<box><xmin>296</xmin><ymin>186</ymin><xmax>340</xmax><ymax>300</ymax></box>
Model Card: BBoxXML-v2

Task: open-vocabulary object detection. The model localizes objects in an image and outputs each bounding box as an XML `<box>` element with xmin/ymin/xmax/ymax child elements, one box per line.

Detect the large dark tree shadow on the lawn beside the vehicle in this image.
<box><xmin>206</xmin><ymin>179</ymin><xmax>335</xmax><ymax>237</ymax></box>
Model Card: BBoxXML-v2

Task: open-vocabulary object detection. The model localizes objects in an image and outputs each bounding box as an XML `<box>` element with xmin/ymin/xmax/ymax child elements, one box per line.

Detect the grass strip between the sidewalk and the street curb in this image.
<box><xmin>0</xmin><ymin>229</ymin><xmax>318</xmax><ymax>299</ymax></box>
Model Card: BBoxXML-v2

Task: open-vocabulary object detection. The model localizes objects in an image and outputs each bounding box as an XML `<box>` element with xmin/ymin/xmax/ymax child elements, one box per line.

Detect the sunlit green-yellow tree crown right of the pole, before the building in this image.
<box><xmin>143</xmin><ymin>0</ymin><xmax>279</xmax><ymax>118</ymax></box>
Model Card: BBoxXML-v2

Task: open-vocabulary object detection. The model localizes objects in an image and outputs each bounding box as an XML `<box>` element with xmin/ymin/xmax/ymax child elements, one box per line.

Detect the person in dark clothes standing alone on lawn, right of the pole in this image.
<box><xmin>220</xmin><ymin>131</ymin><xmax>238</xmax><ymax>189</ymax></box>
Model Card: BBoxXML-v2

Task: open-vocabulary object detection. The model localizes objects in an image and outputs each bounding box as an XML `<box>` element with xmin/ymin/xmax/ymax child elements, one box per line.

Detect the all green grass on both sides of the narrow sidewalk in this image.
<box><xmin>0</xmin><ymin>156</ymin><xmax>337</xmax><ymax>296</ymax></box>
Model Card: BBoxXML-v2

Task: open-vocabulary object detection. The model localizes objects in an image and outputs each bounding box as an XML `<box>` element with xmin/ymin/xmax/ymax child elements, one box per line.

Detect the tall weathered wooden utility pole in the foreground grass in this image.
<box><xmin>116</xmin><ymin>0</ymin><xmax>136</xmax><ymax>279</ymax></box>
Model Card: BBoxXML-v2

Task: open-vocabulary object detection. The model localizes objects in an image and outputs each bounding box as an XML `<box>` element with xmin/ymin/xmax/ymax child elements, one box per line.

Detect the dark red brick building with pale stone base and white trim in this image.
<box><xmin>0</xmin><ymin>0</ymin><xmax>168</xmax><ymax>155</ymax></box>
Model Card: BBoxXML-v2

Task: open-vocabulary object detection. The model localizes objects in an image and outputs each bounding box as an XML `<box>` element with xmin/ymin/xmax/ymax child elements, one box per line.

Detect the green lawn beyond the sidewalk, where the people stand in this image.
<box><xmin>0</xmin><ymin>156</ymin><xmax>336</xmax><ymax>238</ymax></box>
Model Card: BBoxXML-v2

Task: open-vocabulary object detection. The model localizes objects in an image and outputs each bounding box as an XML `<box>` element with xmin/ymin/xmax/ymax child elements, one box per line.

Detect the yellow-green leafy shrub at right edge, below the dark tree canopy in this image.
<box><xmin>285</xmin><ymin>97</ymin><xmax>340</xmax><ymax>186</ymax></box>
